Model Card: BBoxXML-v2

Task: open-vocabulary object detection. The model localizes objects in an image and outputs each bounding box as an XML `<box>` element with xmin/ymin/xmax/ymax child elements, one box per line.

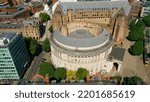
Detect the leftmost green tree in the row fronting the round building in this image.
<box><xmin>38</xmin><ymin>62</ymin><xmax>54</xmax><ymax>78</ymax></box>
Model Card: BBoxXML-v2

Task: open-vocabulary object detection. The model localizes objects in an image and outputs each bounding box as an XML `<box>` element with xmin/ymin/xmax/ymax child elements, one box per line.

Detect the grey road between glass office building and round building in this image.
<box><xmin>23</xmin><ymin>52</ymin><xmax>44</xmax><ymax>81</ymax></box>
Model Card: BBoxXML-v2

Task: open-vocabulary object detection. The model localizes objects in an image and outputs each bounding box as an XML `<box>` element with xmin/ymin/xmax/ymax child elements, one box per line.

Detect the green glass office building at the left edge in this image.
<box><xmin>0</xmin><ymin>32</ymin><xmax>29</xmax><ymax>79</ymax></box>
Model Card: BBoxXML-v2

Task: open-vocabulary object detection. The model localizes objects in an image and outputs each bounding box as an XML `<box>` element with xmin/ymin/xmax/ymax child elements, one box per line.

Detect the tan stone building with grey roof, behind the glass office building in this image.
<box><xmin>0</xmin><ymin>18</ymin><xmax>41</xmax><ymax>40</ymax></box>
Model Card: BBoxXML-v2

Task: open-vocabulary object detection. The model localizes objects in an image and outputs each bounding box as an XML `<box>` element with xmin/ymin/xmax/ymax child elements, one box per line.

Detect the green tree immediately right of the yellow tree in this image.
<box><xmin>76</xmin><ymin>68</ymin><xmax>89</xmax><ymax>80</ymax></box>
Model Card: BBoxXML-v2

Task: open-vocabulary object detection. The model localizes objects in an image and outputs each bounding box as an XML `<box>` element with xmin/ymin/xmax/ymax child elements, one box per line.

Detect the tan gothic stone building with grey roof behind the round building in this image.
<box><xmin>52</xmin><ymin>1</ymin><xmax>131</xmax><ymax>44</ymax></box>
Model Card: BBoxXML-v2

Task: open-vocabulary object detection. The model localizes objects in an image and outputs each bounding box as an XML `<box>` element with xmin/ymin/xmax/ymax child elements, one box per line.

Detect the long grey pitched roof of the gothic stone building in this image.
<box><xmin>59</xmin><ymin>1</ymin><xmax>131</xmax><ymax>16</ymax></box>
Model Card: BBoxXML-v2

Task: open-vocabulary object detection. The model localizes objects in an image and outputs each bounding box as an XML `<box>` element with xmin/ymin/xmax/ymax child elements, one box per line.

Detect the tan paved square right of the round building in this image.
<box><xmin>119</xmin><ymin>39</ymin><xmax>150</xmax><ymax>84</ymax></box>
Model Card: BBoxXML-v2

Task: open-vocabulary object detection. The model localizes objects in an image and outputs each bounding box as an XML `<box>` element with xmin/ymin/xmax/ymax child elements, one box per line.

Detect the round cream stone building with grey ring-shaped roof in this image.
<box><xmin>50</xmin><ymin>22</ymin><xmax>112</xmax><ymax>75</ymax></box>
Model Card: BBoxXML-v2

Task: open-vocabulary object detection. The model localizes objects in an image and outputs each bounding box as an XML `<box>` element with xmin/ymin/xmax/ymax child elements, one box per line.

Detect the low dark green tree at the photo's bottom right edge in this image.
<box><xmin>123</xmin><ymin>76</ymin><xmax>145</xmax><ymax>85</ymax></box>
